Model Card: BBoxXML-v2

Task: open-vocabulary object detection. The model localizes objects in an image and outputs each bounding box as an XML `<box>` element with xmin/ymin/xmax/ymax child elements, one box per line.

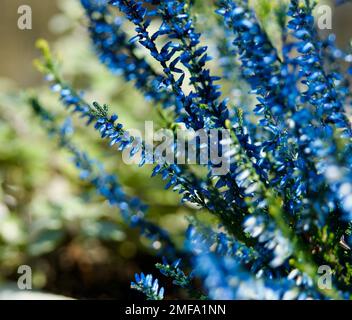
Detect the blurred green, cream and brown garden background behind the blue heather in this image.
<box><xmin>0</xmin><ymin>0</ymin><xmax>352</xmax><ymax>299</ymax></box>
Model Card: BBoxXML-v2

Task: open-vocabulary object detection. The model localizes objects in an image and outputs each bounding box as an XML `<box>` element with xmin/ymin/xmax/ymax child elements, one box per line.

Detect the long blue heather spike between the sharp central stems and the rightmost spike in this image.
<box><xmin>217</xmin><ymin>0</ymin><xmax>306</xmax><ymax>219</ymax></box>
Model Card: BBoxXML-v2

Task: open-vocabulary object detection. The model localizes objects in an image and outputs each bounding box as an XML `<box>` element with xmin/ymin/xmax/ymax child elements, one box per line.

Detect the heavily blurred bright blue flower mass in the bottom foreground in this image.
<box><xmin>187</xmin><ymin>228</ymin><xmax>306</xmax><ymax>300</ymax></box>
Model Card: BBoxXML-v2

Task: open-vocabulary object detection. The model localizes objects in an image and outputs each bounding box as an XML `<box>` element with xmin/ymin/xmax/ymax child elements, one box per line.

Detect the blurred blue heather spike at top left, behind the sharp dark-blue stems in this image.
<box><xmin>81</xmin><ymin>0</ymin><xmax>175</xmax><ymax>107</ymax></box>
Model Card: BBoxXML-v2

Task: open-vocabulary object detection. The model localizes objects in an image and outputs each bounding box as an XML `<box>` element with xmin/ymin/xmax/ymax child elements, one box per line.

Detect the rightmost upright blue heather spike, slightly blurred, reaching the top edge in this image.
<box><xmin>282</xmin><ymin>1</ymin><xmax>351</xmax><ymax>231</ymax></box>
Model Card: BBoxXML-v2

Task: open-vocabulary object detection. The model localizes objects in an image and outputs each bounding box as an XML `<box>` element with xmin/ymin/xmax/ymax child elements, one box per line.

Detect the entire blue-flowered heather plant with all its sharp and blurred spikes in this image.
<box><xmin>29</xmin><ymin>0</ymin><xmax>352</xmax><ymax>300</ymax></box>
